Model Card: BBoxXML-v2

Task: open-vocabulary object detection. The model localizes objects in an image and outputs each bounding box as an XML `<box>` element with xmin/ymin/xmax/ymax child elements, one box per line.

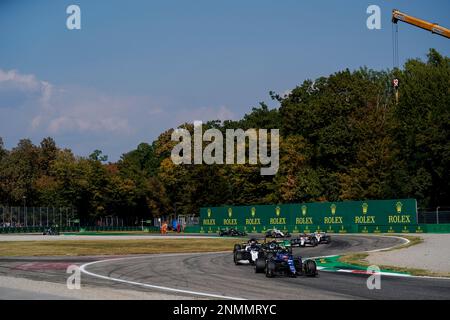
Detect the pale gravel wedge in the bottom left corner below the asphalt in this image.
<box><xmin>0</xmin><ymin>276</ymin><xmax>198</xmax><ymax>300</ymax></box>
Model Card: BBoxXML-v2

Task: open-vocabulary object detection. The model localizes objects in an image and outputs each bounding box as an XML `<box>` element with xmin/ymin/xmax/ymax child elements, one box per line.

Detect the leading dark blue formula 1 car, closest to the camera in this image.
<box><xmin>255</xmin><ymin>243</ymin><xmax>318</xmax><ymax>278</ymax></box>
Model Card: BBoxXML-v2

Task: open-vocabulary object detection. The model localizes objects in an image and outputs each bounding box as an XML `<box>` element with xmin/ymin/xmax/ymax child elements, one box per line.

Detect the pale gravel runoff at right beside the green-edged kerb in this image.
<box><xmin>366</xmin><ymin>233</ymin><xmax>450</xmax><ymax>274</ymax></box>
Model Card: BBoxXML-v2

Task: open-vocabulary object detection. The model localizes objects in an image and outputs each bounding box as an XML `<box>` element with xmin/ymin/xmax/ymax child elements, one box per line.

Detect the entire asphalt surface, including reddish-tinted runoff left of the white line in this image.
<box><xmin>0</xmin><ymin>235</ymin><xmax>450</xmax><ymax>300</ymax></box>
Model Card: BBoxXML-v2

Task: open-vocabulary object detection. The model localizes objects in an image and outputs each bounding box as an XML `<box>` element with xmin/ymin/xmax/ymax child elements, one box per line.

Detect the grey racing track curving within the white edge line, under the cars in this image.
<box><xmin>82</xmin><ymin>236</ymin><xmax>450</xmax><ymax>300</ymax></box>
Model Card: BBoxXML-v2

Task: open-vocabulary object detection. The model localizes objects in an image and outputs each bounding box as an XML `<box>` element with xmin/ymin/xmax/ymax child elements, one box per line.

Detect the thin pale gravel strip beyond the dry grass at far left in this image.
<box><xmin>0</xmin><ymin>234</ymin><xmax>217</xmax><ymax>241</ymax></box>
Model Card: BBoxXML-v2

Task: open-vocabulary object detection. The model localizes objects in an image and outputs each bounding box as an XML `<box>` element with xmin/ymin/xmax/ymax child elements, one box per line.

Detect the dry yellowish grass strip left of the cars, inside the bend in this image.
<box><xmin>0</xmin><ymin>238</ymin><xmax>240</xmax><ymax>256</ymax></box>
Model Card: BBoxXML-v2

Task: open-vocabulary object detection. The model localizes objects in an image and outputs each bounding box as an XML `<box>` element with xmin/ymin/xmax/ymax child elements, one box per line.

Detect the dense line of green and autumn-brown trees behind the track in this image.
<box><xmin>0</xmin><ymin>49</ymin><xmax>450</xmax><ymax>221</ymax></box>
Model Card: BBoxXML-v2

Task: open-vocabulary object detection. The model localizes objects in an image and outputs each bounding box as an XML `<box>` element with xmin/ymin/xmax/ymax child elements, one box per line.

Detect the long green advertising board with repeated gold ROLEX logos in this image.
<box><xmin>200</xmin><ymin>199</ymin><xmax>417</xmax><ymax>233</ymax></box>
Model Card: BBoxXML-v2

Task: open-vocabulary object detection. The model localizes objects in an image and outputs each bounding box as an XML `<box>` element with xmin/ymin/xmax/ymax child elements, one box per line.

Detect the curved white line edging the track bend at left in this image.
<box><xmin>80</xmin><ymin>252</ymin><xmax>245</xmax><ymax>300</ymax></box>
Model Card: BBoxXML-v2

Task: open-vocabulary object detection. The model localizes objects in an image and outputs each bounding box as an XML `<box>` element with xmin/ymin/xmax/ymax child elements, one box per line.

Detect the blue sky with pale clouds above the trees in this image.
<box><xmin>0</xmin><ymin>0</ymin><xmax>450</xmax><ymax>161</ymax></box>
